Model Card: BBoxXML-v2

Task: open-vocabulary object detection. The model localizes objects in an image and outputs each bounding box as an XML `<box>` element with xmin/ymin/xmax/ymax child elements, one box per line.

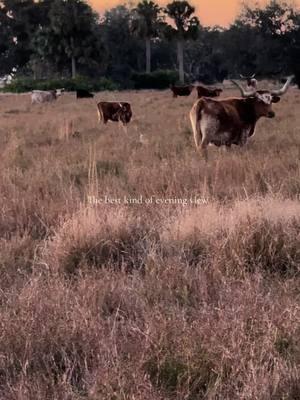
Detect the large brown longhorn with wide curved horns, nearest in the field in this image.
<box><xmin>190</xmin><ymin>77</ymin><xmax>293</xmax><ymax>160</ymax></box>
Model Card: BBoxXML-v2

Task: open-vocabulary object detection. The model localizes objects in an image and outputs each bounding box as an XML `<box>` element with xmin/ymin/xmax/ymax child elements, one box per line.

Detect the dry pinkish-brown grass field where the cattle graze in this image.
<box><xmin>0</xmin><ymin>88</ymin><xmax>300</xmax><ymax>400</ymax></box>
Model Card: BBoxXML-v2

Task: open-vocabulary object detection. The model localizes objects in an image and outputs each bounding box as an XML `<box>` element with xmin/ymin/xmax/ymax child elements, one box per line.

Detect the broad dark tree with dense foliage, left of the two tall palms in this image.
<box><xmin>34</xmin><ymin>0</ymin><xmax>101</xmax><ymax>78</ymax></box>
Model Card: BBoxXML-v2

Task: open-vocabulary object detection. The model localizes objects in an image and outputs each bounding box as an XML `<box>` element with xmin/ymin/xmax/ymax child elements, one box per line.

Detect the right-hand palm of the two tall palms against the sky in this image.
<box><xmin>165</xmin><ymin>0</ymin><xmax>199</xmax><ymax>83</ymax></box>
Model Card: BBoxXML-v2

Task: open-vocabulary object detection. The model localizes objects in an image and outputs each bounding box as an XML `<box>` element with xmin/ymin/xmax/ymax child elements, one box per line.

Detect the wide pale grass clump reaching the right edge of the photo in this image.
<box><xmin>161</xmin><ymin>199</ymin><xmax>300</xmax><ymax>277</ymax></box>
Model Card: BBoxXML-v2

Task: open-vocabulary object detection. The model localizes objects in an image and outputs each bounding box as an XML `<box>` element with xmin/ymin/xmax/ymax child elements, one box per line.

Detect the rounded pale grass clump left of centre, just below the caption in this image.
<box><xmin>39</xmin><ymin>204</ymin><xmax>152</xmax><ymax>274</ymax></box>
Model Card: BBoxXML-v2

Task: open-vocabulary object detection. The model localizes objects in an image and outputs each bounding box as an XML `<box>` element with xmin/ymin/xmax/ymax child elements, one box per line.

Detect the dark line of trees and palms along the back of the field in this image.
<box><xmin>0</xmin><ymin>0</ymin><xmax>300</xmax><ymax>87</ymax></box>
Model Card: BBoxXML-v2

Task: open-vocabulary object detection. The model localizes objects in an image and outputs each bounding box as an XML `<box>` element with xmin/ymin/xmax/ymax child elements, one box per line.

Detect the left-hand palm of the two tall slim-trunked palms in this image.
<box><xmin>131</xmin><ymin>0</ymin><xmax>163</xmax><ymax>73</ymax></box>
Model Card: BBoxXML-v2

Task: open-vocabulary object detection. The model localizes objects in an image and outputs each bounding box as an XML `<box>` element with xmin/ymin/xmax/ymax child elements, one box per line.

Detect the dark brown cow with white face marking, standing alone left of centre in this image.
<box><xmin>97</xmin><ymin>101</ymin><xmax>132</xmax><ymax>125</ymax></box>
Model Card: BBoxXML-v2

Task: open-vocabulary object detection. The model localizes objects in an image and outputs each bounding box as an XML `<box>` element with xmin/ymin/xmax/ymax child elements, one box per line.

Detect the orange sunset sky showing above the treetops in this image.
<box><xmin>89</xmin><ymin>0</ymin><xmax>300</xmax><ymax>26</ymax></box>
